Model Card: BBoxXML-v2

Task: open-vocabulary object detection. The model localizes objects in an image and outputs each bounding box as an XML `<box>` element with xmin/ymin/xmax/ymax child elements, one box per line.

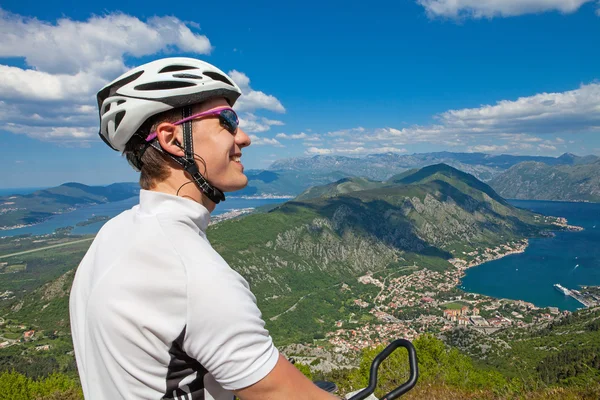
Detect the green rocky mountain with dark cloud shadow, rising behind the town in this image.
<box><xmin>208</xmin><ymin>164</ymin><xmax>558</xmax><ymax>343</ymax></box>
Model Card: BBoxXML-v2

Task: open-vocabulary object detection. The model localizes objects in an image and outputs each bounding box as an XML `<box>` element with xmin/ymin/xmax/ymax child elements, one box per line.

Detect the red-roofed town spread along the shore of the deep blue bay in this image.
<box><xmin>284</xmin><ymin>236</ymin><xmax>600</xmax><ymax>371</ymax></box>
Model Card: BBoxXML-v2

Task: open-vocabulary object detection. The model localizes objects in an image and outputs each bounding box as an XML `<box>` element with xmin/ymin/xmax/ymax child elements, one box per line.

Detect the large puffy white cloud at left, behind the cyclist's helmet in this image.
<box><xmin>0</xmin><ymin>8</ymin><xmax>285</xmax><ymax>142</ymax></box>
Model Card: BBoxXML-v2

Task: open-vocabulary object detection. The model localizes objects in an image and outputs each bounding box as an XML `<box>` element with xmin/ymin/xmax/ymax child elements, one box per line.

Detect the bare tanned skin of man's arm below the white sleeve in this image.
<box><xmin>234</xmin><ymin>355</ymin><xmax>339</xmax><ymax>400</ymax></box>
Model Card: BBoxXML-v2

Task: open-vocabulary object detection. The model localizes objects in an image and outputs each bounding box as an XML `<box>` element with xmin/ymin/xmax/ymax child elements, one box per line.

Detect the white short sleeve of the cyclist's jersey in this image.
<box><xmin>184</xmin><ymin>260</ymin><xmax>279</xmax><ymax>390</ymax></box>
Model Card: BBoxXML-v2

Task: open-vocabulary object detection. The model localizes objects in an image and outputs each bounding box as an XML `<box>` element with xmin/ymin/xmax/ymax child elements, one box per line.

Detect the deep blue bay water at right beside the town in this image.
<box><xmin>460</xmin><ymin>200</ymin><xmax>600</xmax><ymax>311</ymax></box>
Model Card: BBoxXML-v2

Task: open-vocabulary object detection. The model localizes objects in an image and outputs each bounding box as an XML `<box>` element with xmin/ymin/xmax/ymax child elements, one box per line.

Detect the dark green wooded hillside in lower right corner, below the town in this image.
<box><xmin>444</xmin><ymin>307</ymin><xmax>600</xmax><ymax>387</ymax></box>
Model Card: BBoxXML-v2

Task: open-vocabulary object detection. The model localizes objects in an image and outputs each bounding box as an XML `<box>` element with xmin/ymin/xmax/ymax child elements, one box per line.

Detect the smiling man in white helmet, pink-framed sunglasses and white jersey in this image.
<box><xmin>69</xmin><ymin>58</ymin><xmax>336</xmax><ymax>400</ymax></box>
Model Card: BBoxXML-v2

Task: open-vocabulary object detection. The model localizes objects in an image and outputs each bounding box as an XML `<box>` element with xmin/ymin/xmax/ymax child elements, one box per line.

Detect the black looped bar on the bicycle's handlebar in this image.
<box><xmin>348</xmin><ymin>339</ymin><xmax>419</xmax><ymax>400</ymax></box>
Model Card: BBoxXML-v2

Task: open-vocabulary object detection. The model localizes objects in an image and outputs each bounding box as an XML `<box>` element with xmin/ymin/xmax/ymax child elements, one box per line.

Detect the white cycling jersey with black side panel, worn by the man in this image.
<box><xmin>69</xmin><ymin>190</ymin><xmax>279</xmax><ymax>400</ymax></box>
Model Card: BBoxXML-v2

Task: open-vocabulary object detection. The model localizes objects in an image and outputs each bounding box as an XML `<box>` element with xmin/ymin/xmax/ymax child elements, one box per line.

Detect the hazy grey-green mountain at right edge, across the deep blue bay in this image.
<box><xmin>490</xmin><ymin>160</ymin><xmax>600</xmax><ymax>202</ymax></box>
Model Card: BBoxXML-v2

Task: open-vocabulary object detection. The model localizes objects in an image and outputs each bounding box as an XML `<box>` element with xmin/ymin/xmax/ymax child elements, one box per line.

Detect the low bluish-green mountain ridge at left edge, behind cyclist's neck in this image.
<box><xmin>0</xmin><ymin>182</ymin><xmax>140</xmax><ymax>230</ymax></box>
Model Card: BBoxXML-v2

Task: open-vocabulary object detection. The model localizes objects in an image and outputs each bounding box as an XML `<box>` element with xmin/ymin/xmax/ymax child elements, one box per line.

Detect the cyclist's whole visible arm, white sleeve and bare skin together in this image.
<box><xmin>184</xmin><ymin>255</ymin><xmax>337</xmax><ymax>400</ymax></box>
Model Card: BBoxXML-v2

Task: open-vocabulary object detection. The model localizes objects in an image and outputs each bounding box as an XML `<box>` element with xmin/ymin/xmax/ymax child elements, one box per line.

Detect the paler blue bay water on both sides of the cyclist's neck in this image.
<box><xmin>0</xmin><ymin>196</ymin><xmax>288</xmax><ymax>237</ymax></box>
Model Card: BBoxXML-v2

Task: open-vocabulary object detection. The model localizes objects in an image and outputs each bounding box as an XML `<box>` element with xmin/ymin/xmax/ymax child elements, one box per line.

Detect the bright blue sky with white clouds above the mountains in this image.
<box><xmin>0</xmin><ymin>0</ymin><xmax>600</xmax><ymax>187</ymax></box>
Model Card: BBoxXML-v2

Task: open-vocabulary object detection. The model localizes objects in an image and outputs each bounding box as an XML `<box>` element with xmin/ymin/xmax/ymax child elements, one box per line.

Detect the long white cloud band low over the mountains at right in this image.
<box><xmin>292</xmin><ymin>83</ymin><xmax>600</xmax><ymax>158</ymax></box>
